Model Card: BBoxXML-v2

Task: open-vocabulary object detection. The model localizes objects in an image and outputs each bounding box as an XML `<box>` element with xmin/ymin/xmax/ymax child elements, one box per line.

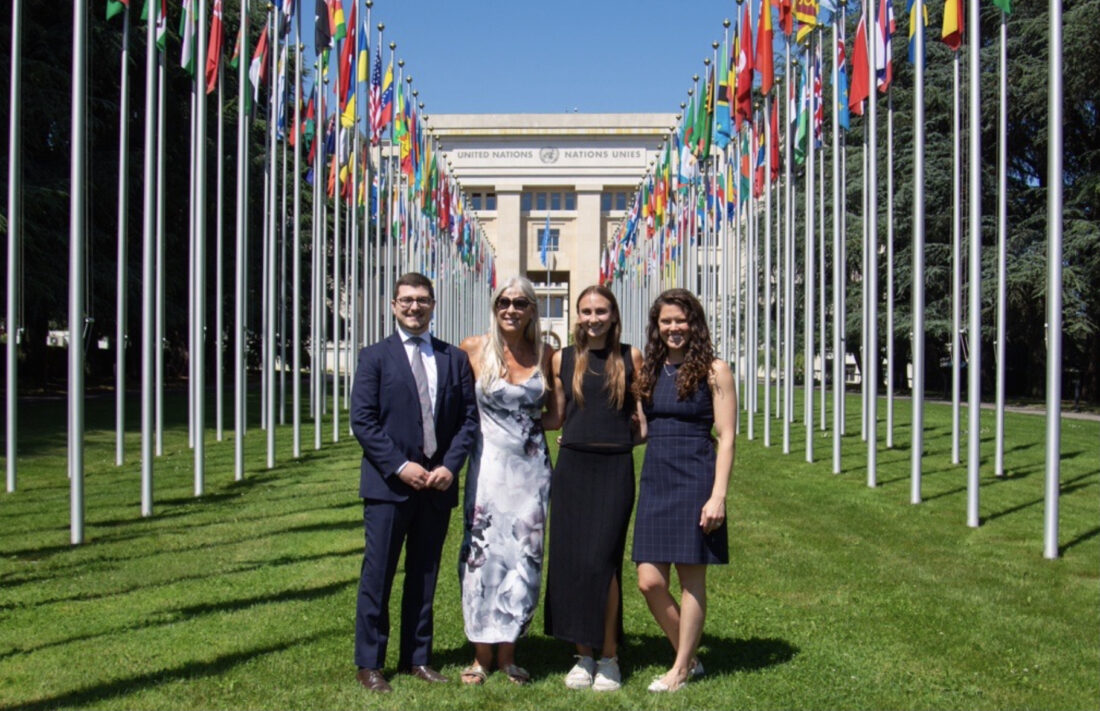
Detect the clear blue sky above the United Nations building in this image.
<box><xmin>308</xmin><ymin>0</ymin><xmax>737</xmax><ymax>114</ymax></box>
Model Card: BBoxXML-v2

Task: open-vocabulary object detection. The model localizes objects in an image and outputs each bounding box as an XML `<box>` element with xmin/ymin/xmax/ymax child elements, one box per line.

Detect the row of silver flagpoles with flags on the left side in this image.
<box><xmin>7</xmin><ymin>0</ymin><xmax>496</xmax><ymax>544</ymax></box>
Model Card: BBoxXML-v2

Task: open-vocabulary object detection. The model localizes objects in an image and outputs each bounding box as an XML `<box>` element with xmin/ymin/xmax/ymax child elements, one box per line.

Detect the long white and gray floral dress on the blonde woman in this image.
<box><xmin>459</xmin><ymin>371</ymin><xmax>550</xmax><ymax>644</ymax></box>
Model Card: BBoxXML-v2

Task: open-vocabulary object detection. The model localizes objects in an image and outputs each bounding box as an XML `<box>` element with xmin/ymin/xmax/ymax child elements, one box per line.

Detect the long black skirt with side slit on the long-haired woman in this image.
<box><xmin>545</xmin><ymin>447</ymin><xmax>635</xmax><ymax>649</ymax></box>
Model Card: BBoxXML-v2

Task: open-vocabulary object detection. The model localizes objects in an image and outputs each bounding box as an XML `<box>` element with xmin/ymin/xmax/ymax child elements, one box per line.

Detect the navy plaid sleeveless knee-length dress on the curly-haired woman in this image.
<box><xmin>633</xmin><ymin>365</ymin><xmax>729</xmax><ymax>565</ymax></box>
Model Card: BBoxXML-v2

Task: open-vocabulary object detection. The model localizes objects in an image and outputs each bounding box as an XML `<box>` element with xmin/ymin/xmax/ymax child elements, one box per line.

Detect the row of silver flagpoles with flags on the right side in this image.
<box><xmin>601</xmin><ymin>0</ymin><xmax>1062</xmax><ymax>558</ymax></box>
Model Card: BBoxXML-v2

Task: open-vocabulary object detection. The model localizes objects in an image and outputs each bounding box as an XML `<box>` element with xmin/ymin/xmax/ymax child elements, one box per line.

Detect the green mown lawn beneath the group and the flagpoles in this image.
<box><xmin>0</xmin><ymin>387</ymin><xmax>1100</xmax><ymax>709</ymax></box>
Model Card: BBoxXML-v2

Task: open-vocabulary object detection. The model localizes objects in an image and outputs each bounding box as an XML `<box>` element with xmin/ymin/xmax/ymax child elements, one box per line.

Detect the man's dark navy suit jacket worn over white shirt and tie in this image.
<box><xmin>351</xmin><ymin>333</ymin><xmax>479</xmax><ymax>507</ymax></box>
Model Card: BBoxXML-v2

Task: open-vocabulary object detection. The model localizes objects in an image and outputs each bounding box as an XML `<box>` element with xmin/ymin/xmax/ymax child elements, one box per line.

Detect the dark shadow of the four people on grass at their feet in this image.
<box><xmin>433</xmin><ymin>633</ymin><xmax>799</xmax><ymax>680</ymax></box>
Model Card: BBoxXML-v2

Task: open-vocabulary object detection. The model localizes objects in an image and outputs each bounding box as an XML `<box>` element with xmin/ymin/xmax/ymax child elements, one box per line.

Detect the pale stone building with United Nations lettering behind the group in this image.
<box><xmin>428</xmin><ymin>113</ymin><xmax>675</xmax><ymax>344</ymax></box>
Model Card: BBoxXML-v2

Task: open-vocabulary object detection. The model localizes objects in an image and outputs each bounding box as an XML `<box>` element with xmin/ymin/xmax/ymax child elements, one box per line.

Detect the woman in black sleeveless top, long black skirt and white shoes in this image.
<box><xmin>543</xmin><ymin>286</ymin><xmax>645</xmax><ymax>691</ymax></box>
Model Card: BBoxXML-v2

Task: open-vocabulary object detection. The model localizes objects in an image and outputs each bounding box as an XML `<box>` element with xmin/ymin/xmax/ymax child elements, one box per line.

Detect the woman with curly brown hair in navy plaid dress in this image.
<box><xmin>634</xmin><ymin>288</ymin><xmax>737</xmax><ymax>691</ymax></box>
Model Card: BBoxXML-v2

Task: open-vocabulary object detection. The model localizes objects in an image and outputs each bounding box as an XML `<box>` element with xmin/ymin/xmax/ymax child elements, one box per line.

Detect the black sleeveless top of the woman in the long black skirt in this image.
<box><xmin>561</xmin><ymin>343</ymin><xmax>635</xmax><ymax>453</ymax></box>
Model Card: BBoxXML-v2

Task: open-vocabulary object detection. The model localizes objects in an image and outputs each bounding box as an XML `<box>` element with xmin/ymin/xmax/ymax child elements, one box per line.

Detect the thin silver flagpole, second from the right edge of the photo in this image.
<box><xmin>993</xmin><ymin>10</ymin><xmax>1009</xmax><ymax>477</ymax></box>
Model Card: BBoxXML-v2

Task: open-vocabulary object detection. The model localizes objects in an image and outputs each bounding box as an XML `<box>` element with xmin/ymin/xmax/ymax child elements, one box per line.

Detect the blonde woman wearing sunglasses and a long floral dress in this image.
<box><xmin>459</xmin><ymin>277</ymin><xmax>557</xmax><ymax>685</ymax></box>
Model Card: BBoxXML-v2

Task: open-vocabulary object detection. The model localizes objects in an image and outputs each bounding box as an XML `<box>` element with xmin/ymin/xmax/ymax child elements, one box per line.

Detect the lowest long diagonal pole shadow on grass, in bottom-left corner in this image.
<box><xmin>9</xmin><ymin>633</ymin><xmax>328</xmax><ymax>711</ymax></box>
